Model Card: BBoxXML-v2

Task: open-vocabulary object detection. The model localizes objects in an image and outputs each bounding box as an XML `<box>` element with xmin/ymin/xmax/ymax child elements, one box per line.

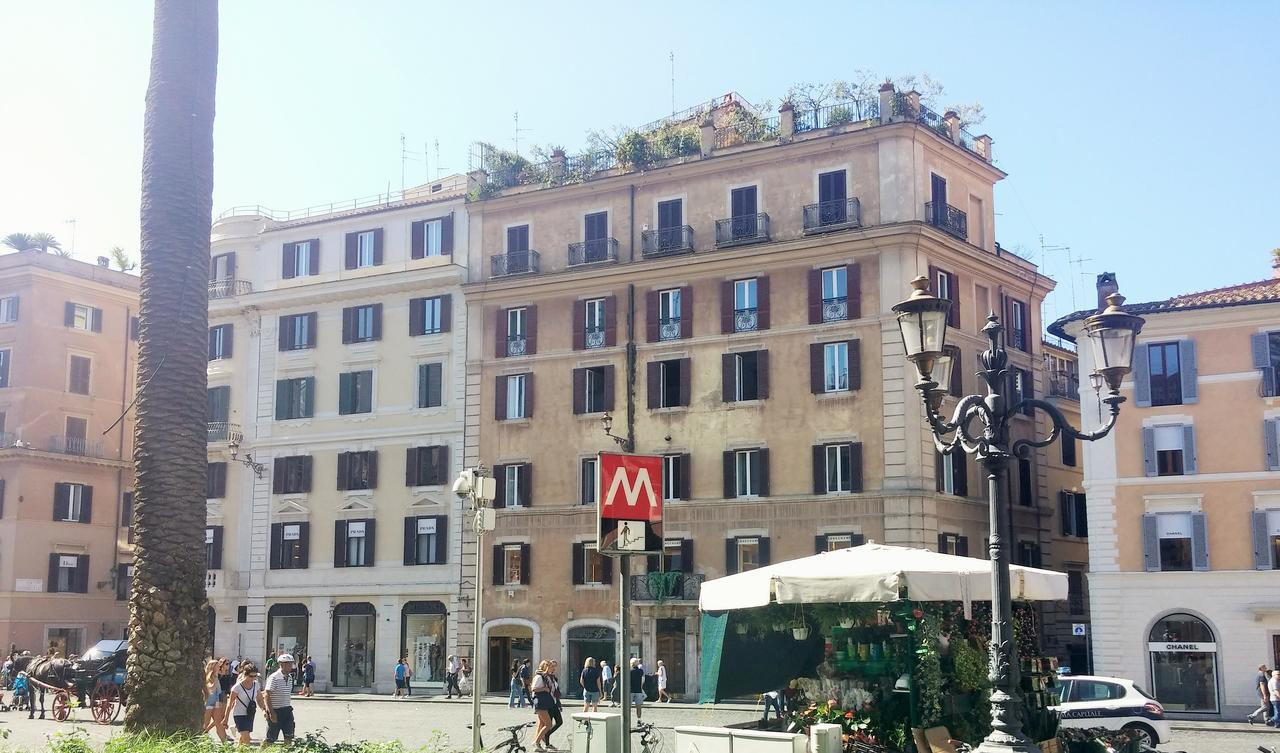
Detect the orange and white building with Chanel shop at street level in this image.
<box><xmin>1051</xmin><ymin>264</ymin><xmax>1280</xmax><ymax>720</ymax></box>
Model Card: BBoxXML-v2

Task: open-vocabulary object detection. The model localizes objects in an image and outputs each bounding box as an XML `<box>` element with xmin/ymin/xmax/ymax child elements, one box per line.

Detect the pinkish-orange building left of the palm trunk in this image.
<box><xmin>0</xmin><ymin>252</ymin><xmax>138</xmax><ymax>656</ymax></box>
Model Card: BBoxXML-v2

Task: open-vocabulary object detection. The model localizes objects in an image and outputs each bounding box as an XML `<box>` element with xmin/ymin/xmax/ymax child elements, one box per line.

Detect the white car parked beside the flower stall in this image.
<box><xmin>1055</xmin><ymin>675</ymin><xmax>1172</xmax><ymax>747</ymax></box>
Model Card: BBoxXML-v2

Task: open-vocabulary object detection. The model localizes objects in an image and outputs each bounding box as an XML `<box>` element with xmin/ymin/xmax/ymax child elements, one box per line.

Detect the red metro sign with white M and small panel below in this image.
<box><xmin>595</xmin><ymin>452</ymin><xmax>662</xmax><ymax>555</ymax></box>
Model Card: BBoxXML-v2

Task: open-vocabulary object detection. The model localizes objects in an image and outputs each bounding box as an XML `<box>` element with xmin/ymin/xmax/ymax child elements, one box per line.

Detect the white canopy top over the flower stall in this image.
<box><xmin>698</xmin><ymin>544</ymin><xmax>1066</xmax><ymax>612</ymax></box>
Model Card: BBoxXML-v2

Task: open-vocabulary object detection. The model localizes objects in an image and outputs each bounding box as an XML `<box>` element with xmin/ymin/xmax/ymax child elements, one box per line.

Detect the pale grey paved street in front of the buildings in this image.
<box><xmin>0</xmin><ymin>697</ymin><xmax>1280</xmax><ymax>753</ymax></box>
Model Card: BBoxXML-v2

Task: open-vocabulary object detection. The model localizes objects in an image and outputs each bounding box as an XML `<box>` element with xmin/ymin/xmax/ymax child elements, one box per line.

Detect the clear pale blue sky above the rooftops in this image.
<box><xmin>0</xmin><ymin>0</ymin><xmax>1280</xmax><ymax>323</ymax></box>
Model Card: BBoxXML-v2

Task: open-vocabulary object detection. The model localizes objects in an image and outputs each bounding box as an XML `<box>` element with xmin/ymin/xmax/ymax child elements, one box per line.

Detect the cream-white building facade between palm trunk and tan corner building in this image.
<box><xmin>206</xmin><ymin>177</ymin><xmax>470</xmax><ymax>692</ymax></box>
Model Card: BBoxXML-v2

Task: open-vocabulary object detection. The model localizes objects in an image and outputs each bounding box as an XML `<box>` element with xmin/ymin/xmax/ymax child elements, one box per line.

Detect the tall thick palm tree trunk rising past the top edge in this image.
<box><xmin>124</xmin><ymin>0</ymin><xmax>218</xmax><ymax>735</ymax></box>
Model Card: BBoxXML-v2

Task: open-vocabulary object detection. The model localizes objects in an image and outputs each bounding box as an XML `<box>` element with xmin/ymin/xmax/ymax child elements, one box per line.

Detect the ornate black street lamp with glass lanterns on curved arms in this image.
<box><xmin>893</xmin><ymin>277</ymin><xmax>1143</xmax><ymax>753</ymax></box>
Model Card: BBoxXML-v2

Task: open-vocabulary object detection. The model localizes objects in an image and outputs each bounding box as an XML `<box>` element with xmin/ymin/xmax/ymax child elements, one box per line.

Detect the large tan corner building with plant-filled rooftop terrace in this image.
<box><xmin>463</xmin><ymin>87</ymin><xmax>1083</xmax><ymax>697</ymax></box>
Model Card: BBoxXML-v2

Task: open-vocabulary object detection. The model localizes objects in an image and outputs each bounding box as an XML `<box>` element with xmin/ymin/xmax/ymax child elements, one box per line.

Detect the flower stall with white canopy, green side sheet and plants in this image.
<box><xmin>699</xmin><ymin>544</ymin><xmax>1066</xmax><ymax>750</ymax></box>
